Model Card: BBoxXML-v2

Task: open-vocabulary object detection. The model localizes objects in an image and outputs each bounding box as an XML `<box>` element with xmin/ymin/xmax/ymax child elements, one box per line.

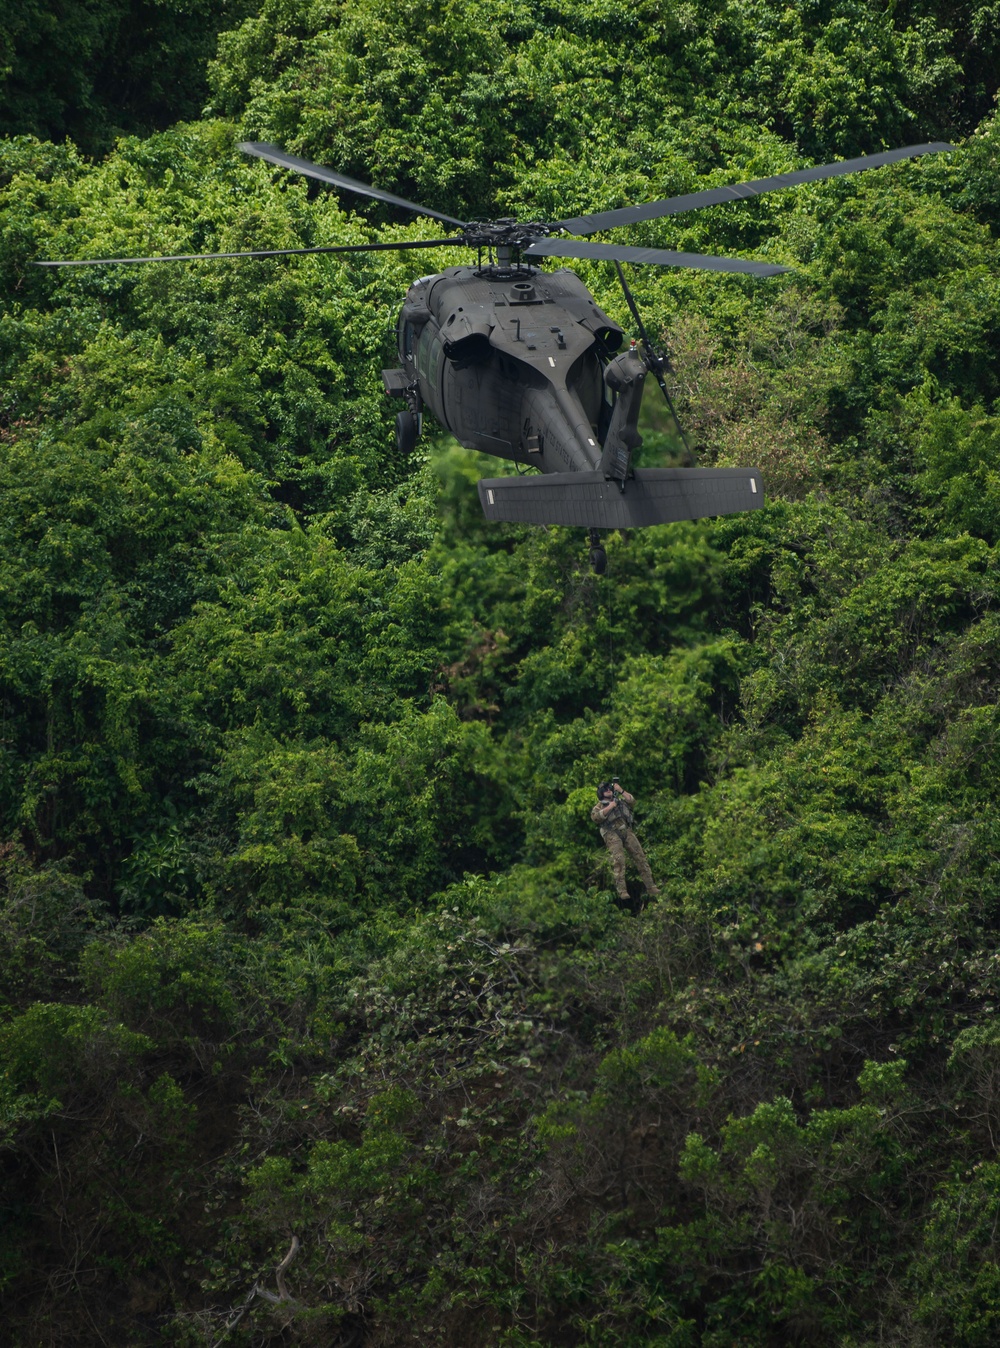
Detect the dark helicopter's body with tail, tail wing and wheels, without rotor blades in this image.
<box><xmin>383</xmin><ymin>264</ymin><xmax>764</xmax><ymax>560</ymax></box>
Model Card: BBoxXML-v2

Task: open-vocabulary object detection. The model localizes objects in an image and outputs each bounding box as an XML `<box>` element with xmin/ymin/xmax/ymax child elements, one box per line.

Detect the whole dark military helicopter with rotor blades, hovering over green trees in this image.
<box><xmin>39</xmin><ymin>142</ymin><xmax>954</xmax><ymax>573</ymax></box>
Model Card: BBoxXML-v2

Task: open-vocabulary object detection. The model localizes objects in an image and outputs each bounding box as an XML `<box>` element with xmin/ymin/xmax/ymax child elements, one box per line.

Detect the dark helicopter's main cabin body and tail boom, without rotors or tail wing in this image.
<box><xmin>385</xmin><ymin>264</ymin><xmax>633</xmax><ymax>473</ymax></box>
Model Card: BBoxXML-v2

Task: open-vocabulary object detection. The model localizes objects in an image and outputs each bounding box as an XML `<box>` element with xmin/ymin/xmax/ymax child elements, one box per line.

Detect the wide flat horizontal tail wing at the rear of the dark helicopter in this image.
<box><xmin>478</xmin><ymin>468</ymin><xmax>764</xmax><ymax>528</ymax></box>
